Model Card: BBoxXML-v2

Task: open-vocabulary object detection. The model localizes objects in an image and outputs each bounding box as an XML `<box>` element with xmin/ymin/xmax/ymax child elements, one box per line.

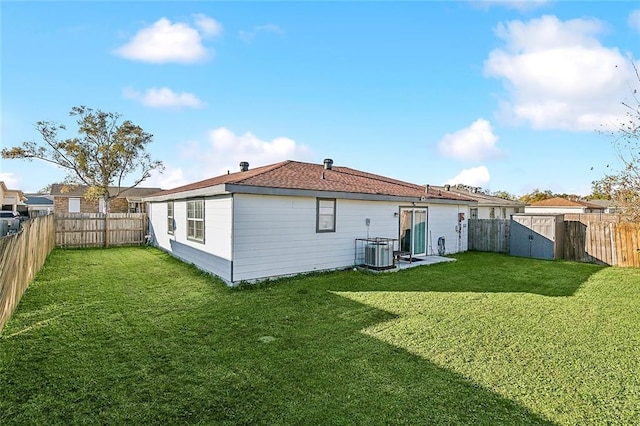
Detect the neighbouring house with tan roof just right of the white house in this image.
<box><xmin>424</xmin><ymin>185</ymin><xmax>526</xmax><ymax>219</ymax></box>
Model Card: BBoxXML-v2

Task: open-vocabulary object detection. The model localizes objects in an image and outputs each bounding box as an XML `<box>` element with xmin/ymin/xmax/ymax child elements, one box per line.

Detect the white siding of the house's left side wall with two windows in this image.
<box><xmin>149</xmin><ymin>197</ymin><xmax>232</xmax><ymax>281</ymax></box>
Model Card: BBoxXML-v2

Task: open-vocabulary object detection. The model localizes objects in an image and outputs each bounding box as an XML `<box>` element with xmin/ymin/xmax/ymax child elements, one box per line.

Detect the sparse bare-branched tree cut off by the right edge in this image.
<box><xmin>592</xmin><ymin>61</ymin><xmax>640</xmax><ymax>222</ymax></box>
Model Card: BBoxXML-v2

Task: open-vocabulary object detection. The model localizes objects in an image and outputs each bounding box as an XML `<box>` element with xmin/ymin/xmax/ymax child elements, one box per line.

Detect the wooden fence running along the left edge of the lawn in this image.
<box><xmin>0</xmin><ymin>215</ymin><xmax>54</xmax><ymax>331</ymax></box>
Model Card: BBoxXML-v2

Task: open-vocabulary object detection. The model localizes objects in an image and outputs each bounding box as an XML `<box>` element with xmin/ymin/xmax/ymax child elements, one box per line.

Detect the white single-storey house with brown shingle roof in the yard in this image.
<box><xmin>144</xmin><ymin>159</ymin><xmax>476</xmax><ymax>285</ymax></box>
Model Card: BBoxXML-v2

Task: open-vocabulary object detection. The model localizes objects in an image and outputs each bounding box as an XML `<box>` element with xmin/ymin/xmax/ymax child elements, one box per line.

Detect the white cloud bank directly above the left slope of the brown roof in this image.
<box><xmin>181</xmin><ymin>127</ymin><xmax>311</xmax><ymax>179</ymax></box>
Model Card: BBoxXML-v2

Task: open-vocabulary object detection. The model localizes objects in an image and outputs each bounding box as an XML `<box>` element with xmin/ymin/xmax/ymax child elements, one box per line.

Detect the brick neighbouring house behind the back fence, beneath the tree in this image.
<box><xmin>51</xmin><ymin>183</ymin><xmax>162</xmax><ymax>213</ymax></box>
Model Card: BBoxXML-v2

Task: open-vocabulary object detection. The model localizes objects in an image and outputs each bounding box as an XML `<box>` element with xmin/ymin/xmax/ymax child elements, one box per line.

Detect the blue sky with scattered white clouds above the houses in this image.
<box><xmin>0</xmin><ymin>1</ymin><xmax>640</xmax><ymax>195</ymax></box>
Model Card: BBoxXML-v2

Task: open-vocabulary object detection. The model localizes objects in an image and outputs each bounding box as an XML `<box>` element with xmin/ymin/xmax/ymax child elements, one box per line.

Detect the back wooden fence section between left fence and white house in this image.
<box><xmin>55</xmin><ymin>213</ymin><xmax>147</xmax><ymax>248</ymax></box>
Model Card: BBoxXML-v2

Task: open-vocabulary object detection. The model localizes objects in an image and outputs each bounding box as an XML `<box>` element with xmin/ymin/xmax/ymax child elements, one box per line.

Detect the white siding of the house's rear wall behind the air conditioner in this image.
<box><xmin>233</xmin><ymin>194</ymin><xmax>468</xmax><ymax>282</ymax></box>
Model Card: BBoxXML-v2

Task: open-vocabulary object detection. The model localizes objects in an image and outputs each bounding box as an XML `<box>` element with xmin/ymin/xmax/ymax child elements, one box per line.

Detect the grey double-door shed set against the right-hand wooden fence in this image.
<box><xmin>509</xmin><ymin>214</ymin><xmax>564</xmax><ymax>260</ymax></box>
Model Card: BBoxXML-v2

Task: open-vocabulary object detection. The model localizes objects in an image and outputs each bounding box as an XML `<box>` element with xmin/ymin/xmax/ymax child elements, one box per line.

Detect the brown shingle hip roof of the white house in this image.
<box><xmin>147</xmin><ymin>160</ymin><xmax>473</xmax><ymax>202</ymax></box>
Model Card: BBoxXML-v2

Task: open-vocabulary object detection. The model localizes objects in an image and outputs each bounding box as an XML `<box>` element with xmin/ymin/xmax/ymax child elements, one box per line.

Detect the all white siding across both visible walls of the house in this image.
<box><xmin>149</xmin><ymin>194</ymin><xmax>468</xmax><ymax>283</ymax></box>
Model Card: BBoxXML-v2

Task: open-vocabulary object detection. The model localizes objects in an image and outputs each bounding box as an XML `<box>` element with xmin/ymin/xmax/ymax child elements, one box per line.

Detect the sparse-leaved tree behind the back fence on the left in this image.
<box><xmin>1</xmin><ymin>106</ymin><xmax>164</xmax><ymax>210</ymax></box>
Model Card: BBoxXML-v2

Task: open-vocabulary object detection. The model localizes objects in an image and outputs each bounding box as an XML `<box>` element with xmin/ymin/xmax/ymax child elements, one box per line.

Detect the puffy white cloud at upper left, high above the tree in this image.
<box><xmin>115</xmin><ymin>15</ymin><xmax>222</xmax><ymax>63</ymax></box>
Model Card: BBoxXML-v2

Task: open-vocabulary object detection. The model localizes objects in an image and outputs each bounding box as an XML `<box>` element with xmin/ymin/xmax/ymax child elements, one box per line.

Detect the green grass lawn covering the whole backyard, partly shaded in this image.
<box><xmin>0</xmin><ymin>248</ymin><xmax>640</xmax><ymax>425</ymax></box>
